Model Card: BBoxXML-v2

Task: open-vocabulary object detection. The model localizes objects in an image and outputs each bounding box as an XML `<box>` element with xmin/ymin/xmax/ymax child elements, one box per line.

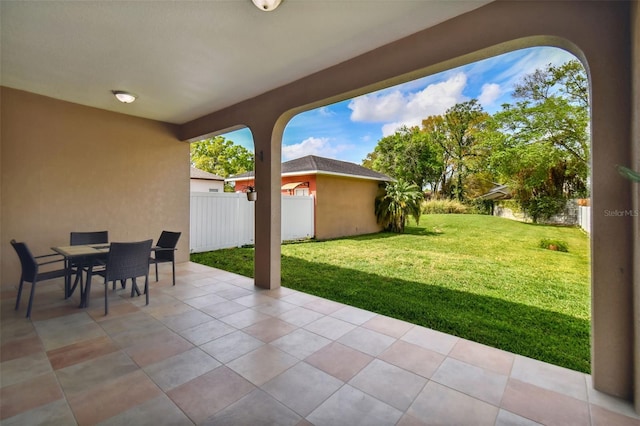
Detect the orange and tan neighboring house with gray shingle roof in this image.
<box><xmin>226</xmin><ymin>155</ymin><xmax>392</xmax><ymax>240</ymax></box>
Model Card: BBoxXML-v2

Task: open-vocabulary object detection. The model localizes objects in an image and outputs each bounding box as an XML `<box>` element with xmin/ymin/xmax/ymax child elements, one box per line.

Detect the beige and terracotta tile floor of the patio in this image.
<box><xmin>0</xmin><ymin>263</ymin><xmax>640</xmax><ymax>426</ymax></box>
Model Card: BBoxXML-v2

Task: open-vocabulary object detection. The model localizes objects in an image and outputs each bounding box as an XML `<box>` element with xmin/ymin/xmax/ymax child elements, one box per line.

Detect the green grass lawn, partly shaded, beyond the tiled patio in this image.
<box><xmin>191</xmin><ymin>215</ymin><xmax>590</xmax><ymax>373</ymax></box>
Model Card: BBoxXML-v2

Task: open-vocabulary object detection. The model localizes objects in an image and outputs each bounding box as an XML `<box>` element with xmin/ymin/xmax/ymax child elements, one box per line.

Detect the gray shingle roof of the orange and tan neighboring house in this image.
<box><xmin>227</xmin><ymin>155</ymin><xmax>393</xmax><ymax>181</ymax></box>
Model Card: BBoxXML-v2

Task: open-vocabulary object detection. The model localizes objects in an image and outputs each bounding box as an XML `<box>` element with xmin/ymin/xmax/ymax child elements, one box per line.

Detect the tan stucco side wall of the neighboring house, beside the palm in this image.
<box><xmin>316</xmin><ymin>175</ymin><xmax>381</xmax><ymax>240</ymax></box>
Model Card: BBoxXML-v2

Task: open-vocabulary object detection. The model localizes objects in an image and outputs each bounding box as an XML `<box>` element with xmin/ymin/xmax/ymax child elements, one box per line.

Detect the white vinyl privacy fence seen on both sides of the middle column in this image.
<box><xmin>190</xmin><ymin>192</ymin><xmax>314</xmax><ymax>253</ymax></box>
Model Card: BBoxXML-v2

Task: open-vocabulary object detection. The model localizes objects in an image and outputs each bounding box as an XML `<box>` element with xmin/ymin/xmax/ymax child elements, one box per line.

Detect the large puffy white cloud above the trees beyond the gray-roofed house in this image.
<box><xmin>349</xmin><ymin>72</ymin><xmax>467</xmax><ymax>136</ymax></box>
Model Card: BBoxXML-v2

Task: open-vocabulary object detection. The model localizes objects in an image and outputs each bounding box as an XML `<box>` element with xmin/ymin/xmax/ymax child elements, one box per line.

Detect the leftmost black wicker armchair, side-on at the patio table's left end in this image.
<box><xmin>11</xmin><ymin>240</ymin><xmax>67</xmax><ymax>318</ymax></box>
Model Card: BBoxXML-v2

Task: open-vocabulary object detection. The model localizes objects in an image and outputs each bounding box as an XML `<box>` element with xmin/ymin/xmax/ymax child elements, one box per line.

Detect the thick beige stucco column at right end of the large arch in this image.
<box><xmin>588</xmin><ymin>3</ymin><xmax>637</xmax><ymax>399</ymax></box>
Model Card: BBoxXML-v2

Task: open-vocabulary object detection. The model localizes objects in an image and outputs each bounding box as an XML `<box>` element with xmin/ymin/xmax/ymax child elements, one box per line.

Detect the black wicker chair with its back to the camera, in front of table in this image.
<box><xmin>86</xmin><ymin>240</ymin><xmax>153</xmax><ymax>315</ymax></box>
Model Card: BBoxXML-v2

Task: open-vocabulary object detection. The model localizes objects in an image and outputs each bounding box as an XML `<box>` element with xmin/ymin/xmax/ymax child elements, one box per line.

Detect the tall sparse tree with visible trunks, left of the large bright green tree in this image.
<box><xmin>422</xmin><ymin>99</ymin><xmax>489</xmax><ymax>202</ymax></box>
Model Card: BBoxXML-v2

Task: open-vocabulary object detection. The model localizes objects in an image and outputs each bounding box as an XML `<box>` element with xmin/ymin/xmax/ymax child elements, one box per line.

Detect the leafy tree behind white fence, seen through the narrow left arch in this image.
<box><xmin>191</xmin><ymin>136</ymin><xmax>254</xmax><ymax>178</ymax></box>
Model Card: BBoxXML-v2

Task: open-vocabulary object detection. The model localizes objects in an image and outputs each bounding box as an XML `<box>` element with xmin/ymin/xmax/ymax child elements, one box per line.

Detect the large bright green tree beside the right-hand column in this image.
<box><xmin>485</xmin><ymin>61</ymin><xmax>590</xmax><ymax>221</ymax></box>
